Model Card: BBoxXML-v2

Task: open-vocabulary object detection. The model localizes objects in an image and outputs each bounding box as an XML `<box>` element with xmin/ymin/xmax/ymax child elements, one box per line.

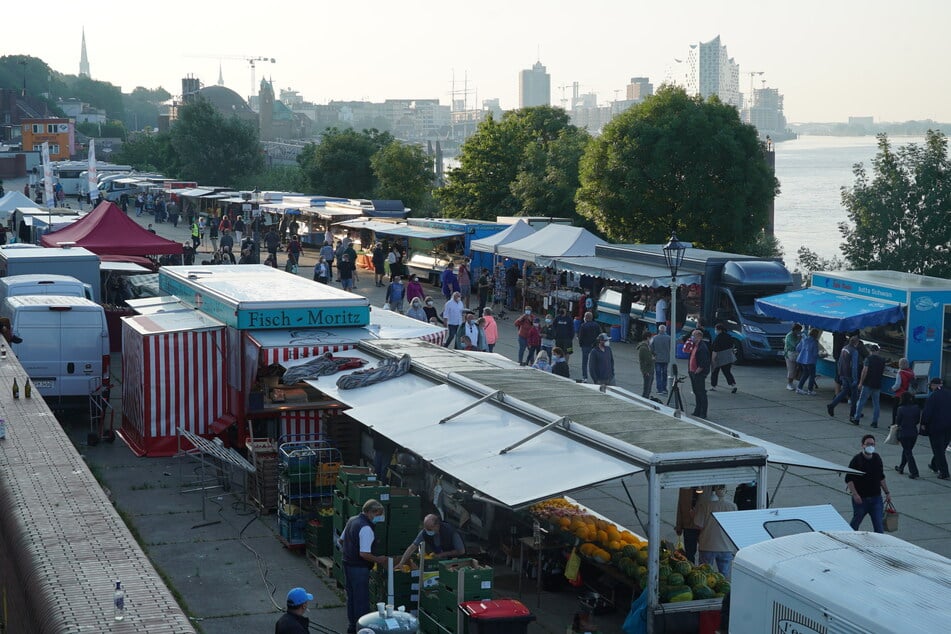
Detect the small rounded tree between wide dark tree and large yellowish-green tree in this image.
<box><xmin>370</xmin><ymin>141</ymin><xmax>435</xmax><ymax>216</ymax></box>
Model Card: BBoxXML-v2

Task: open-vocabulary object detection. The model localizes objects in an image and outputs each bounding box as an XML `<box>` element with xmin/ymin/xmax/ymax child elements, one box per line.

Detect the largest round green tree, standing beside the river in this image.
<box><xmin>577</xmin><ymin>86</ymin><xmax>779</xmax><ymax>253</ymax></box>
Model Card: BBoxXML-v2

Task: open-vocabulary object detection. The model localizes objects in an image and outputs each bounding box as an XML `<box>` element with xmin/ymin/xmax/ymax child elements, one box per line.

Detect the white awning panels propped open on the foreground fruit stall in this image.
<box><xmin>344</xmin><ymin>383</ymin><xmax>642</xmax><ymax>508</ymax></box>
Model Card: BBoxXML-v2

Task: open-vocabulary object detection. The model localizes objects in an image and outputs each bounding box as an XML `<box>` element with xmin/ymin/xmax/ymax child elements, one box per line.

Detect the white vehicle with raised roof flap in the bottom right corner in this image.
<box><xmin>713</xmin><ymin>504</ymin><xmax>951</xmax><ymax>634</ymax></box>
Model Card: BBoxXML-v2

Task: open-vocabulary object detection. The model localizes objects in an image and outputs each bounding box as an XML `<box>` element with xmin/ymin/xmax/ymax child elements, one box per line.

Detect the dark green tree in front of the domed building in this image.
<box><xmin>171</xmin><ymin>99</ymin><xmax>264</xmax><ymax>185</ymax></box>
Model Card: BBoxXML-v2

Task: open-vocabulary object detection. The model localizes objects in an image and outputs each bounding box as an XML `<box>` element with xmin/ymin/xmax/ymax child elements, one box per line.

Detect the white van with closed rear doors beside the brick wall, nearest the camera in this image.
<box><xmin>0</xmin><ymin>295</ymin><xmax>109</xmax><ymax>400</ymax></box>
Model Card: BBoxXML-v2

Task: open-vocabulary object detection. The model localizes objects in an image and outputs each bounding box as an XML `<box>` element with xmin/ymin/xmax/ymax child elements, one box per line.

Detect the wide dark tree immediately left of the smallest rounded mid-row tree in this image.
<box><xmin>297</xmin><ymin>128</ymin><xmax>393</xmax><ymax>198</ymax></box>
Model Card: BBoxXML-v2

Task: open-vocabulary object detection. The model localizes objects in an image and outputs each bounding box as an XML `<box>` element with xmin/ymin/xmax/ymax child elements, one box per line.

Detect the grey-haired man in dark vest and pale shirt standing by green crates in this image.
<box><xmin>338</xmin><ymin>499</ymin><xmax>390</xmax><ymax>634</ymax></box>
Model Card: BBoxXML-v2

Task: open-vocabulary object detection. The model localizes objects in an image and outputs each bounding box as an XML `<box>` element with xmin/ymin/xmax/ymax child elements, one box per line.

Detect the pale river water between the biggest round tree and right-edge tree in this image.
<box><xmin>775</xmin><ymin>136</ymin><xmax>924</xmax><ymax>267</ymax></box>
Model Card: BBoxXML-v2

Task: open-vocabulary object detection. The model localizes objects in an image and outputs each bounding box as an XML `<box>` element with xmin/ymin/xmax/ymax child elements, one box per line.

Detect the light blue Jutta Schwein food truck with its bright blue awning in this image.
<box><xmin>756</xmin><ymin>271</ymin><xmax>951</xmax><ymax>394</ymax></box>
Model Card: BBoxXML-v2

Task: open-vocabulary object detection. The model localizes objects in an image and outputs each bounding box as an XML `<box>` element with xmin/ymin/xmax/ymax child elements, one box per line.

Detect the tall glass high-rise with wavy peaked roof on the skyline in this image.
<box><xmin>671</xmin><ymin>35</ymin><xmax>743</xmax><ymax>108</ymax></box>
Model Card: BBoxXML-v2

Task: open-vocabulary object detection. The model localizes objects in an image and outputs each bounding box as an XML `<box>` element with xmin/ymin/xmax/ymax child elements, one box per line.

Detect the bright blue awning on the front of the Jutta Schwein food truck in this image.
<box><xmin>756</xmin><ymin>288</ymin><xmax>905</xmax><ymax>332</ymax></box>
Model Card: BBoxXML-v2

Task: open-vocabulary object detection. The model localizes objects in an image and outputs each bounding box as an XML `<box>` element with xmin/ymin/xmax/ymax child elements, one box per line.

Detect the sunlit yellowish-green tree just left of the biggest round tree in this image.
<box><xmin>436</xmin><ymin>106</ymin><xmax>590</xmax><ymax>225</ymax></box>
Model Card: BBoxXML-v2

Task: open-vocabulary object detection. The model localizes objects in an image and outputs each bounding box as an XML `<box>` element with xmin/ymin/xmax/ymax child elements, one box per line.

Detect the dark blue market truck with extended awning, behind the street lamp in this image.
<box><xmin>595</xmin><ymin>244</ymin><xmax>793</xmax><ymax>361</ymax></box>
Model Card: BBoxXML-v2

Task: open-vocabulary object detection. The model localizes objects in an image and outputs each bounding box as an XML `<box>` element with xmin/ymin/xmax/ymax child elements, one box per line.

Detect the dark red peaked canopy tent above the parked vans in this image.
<box><xmin>40</xmin><ymin>201</ymin><xmax>182</xmax><ymax>255</ymax></box>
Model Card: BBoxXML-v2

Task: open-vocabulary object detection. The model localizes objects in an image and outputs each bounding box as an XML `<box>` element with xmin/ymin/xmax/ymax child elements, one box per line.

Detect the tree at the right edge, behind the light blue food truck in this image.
<box><xmin>839</xmin><ymin>130</ymin><xmax>951</xmax><ymax>278</ymax></box>
